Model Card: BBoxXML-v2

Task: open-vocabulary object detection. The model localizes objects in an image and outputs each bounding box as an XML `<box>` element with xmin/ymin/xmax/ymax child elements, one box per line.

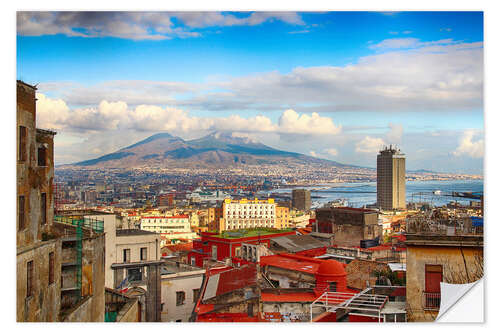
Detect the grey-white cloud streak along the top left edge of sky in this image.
<box><xmin>17</xmin><ymin>11</ymin><xmax>304</xmax><ymax>40</ymax></box>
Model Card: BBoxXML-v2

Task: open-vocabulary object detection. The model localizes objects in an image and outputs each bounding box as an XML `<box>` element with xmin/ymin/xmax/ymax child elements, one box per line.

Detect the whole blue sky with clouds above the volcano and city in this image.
<box><xmin>17</xmin><ymin>12</ymin><xmax>484</xmax><ymax>174</ymax></box>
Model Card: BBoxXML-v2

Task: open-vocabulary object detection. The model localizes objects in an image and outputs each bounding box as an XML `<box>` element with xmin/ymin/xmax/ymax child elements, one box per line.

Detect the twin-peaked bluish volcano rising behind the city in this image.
<box><xmin>73</xmin><ymin>132</ymin><xmax>352</xmax><ymax>168</ymax></box>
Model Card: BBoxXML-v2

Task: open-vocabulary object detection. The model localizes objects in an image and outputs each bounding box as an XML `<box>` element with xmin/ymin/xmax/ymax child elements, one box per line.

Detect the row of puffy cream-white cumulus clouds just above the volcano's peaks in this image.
<box><xmin>37</xmin><ymin>93</ymin><xmax>341</xmax><ymax>136</ymax></box>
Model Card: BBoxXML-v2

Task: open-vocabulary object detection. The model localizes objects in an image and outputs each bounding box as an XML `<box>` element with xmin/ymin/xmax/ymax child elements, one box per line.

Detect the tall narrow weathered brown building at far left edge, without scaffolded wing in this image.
<box><xmin>16</xmin><ymin>81</ymin><xmax>61</xmax><ymax>321</ymax></box>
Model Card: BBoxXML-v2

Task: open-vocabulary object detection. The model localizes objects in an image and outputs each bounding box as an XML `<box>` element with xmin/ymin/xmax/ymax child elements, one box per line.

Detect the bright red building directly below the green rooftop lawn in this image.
<box><xmin>188</xmin><ymin>230</ymin><xmax>295</xmax><ymax>267</ymax></box>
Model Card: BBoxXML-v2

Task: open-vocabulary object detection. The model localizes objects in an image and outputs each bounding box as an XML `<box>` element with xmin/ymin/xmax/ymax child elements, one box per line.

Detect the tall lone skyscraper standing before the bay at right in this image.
<box><xmin>377</xmin><ymin>146</ymin><xmax>406</xmax><ymax>210</ymax></box>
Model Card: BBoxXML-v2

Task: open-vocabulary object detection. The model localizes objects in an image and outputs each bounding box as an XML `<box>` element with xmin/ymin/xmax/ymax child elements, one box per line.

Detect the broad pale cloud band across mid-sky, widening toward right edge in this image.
<box><xmin>39</xmin><ymin>39</ymin><xmax>483</xmax><ymax>113</ymax></box>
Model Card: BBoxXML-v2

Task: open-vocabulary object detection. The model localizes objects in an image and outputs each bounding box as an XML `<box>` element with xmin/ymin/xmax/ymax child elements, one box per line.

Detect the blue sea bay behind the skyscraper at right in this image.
<box><xmin>258</xmin><ymin>180</ymin><xmax>483</xmax><ymax>208</ymax></box>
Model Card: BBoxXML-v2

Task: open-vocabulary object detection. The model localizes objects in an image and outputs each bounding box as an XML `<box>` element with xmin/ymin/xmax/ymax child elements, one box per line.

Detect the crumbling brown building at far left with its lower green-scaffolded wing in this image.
<box><xmin>16</xmin><ymin>81</ymin><xmax>105</xmax><ymax>322</ymax></box>
